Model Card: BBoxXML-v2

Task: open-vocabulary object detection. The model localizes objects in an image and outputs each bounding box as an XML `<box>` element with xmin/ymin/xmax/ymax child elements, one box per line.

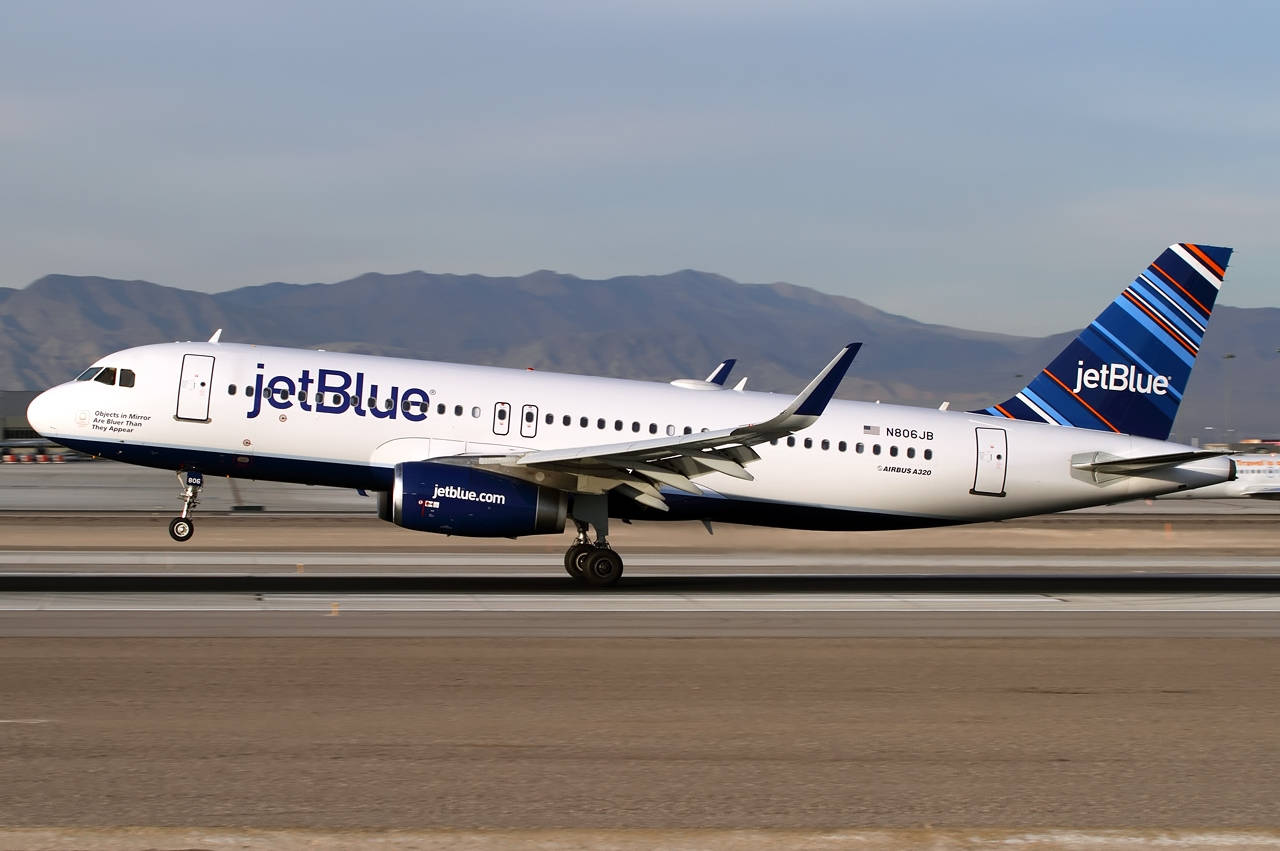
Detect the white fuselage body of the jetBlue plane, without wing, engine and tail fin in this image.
<box><xmin>28</xmin><ymin>343</ymin><xmax>1231</xmax><ymax>529</ymax></box>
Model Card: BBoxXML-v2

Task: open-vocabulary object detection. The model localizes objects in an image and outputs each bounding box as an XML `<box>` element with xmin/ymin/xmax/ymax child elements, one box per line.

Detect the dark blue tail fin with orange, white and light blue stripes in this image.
<box><xmin>972</xmin><ymin>242</ymin><xmax>1231</xmax><ymax>440</ymax></box>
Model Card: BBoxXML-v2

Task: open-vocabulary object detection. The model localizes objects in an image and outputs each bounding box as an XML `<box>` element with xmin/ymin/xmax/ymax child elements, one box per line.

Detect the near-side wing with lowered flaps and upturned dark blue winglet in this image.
<box><xmin>431</xmin><ymin>343</ymin><xmax>863</xmax><ymax>511</ymax></box>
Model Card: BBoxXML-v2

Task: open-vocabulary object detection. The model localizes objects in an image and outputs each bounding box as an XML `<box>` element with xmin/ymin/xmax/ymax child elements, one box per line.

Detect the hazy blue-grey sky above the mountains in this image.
<box><xmin>0</xmin><ymin>0</ymin><xmax>1280</xmax><ymax>333</ymax></box>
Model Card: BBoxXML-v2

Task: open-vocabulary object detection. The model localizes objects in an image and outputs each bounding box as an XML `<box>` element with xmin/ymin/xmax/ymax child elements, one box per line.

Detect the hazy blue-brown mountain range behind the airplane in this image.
<box><xmin>0</xmin><ymin>270</ymin><xmax>1280</xmax><ymax>440</ymax></box>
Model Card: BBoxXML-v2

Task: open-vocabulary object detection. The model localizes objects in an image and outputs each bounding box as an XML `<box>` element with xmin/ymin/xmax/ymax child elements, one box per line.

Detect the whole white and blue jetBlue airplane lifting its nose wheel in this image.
<box><xmin>27</xmin><ymin>243</ymin><xmax>1236</xmax><ymax>587</ymax></box>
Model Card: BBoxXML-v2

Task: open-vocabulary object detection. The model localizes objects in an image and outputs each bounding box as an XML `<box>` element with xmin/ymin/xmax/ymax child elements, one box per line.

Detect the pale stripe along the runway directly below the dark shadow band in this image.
<box><xmin>10</xmin><ymin>591</ymin><xmax>1280</xmax><ymax>613</ymax></box>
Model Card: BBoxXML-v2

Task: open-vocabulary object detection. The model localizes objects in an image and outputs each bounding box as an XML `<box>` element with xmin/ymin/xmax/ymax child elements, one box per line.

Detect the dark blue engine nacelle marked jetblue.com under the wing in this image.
<box><xmin>378</xmin><ymin>461</ymin><xmax>568</xmax><ymax>537</ymax></box>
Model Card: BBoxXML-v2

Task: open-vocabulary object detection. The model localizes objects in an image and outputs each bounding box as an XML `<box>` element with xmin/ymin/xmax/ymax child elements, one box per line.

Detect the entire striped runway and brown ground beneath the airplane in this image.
<box><xmin>0</xmin><ymin>491</ymin><xmax>1280</xmax><ymax>829</ymax></box>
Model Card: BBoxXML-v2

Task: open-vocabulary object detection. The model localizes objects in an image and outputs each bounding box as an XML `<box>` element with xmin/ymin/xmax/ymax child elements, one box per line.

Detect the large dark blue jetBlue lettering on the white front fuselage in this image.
<box><xmin>244</xmin><ymin>363</ymin><xmax>430</xmax><ymax>422</ymax></box>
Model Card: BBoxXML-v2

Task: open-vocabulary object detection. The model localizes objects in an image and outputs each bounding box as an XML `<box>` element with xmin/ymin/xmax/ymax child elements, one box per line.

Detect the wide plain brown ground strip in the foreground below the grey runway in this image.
<box><xmin>0</xmin><ymin>637</ymin><xmax>1280</xmax><ymax>829</ymax></box>
